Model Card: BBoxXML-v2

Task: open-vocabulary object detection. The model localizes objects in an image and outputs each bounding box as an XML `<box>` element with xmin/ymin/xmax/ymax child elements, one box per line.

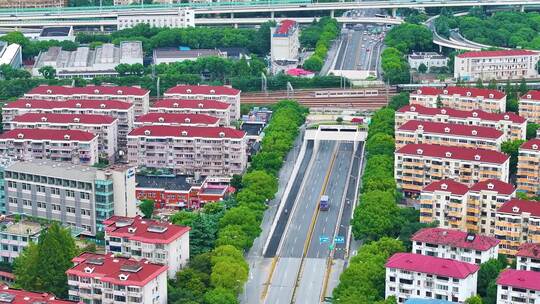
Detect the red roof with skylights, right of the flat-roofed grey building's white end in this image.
<box><xmin>103</xmin><ymin>216</ymin><xmax>191</xmax><ymax>244</ymax></box>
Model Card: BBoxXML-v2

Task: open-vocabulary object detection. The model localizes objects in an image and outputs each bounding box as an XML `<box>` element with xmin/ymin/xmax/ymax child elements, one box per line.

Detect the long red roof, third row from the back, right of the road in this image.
<box><xmin>398</xmin><ymin>120</ymin><xmax>504</xmax><ymax>139</ymax></box>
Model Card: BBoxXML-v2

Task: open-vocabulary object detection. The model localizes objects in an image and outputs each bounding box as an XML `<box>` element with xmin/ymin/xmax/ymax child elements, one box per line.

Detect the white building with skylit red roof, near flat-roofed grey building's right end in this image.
<box><xmin>103</xmin><ymin>216</ymin><xmax>190</xmax><ymax>279</ymax></box>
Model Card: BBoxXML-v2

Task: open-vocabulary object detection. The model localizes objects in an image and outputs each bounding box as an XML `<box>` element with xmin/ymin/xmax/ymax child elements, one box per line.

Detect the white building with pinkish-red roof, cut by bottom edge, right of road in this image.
<box><xmin>385</xmin><ymin>253</ymin><xmax>480</xmax><ymax>303</ymax></box>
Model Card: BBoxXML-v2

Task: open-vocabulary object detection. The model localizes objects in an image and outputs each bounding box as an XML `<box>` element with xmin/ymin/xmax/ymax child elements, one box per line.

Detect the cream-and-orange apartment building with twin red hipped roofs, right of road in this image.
<box><xmin>420</xmin><ymin>179</ymin><xmax>516</xmax><ymax>236</ymax></box>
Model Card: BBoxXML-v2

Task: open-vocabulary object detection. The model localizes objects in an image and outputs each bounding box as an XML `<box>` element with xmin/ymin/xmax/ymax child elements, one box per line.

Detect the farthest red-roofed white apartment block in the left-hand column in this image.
<box><xmin>24</xmin><ymin>85</ymin><xmax>150</xmax><ymax>116</ymax></box>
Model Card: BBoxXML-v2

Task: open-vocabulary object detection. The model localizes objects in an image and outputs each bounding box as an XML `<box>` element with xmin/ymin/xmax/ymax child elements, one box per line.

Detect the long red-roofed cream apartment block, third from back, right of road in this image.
<box><xmin>395</xmin><ymin>120</ymin><xmax>504</xmax><ymax>151</ymax></box>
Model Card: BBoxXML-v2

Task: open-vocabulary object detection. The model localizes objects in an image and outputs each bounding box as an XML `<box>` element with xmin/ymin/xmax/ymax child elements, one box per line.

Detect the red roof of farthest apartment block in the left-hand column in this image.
<box><xmin>25</xmin><ymin>85</ymin><xmax>150</xmax><ymax>96</ymax></box>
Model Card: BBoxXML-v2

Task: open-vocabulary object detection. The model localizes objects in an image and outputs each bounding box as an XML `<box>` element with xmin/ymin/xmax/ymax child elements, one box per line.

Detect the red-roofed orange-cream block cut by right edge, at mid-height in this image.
<box><xmin>516</xmin><ymin>138</ymin><xmax>540</xmax><ymax>196</ymax></box>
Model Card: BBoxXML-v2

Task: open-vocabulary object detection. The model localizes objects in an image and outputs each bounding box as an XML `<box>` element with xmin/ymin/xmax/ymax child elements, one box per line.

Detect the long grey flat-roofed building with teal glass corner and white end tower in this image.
<box><xmin>0</xmin><ymin>160</ymin><xmax>137</xmax><ymax>236</ymax></box>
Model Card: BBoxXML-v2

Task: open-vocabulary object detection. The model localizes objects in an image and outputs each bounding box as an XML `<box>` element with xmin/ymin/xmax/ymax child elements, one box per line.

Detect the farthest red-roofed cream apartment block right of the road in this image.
<box><xmin>409</xmin><ymin>87</ymin><xmax>506</xmax><ymax>113</ymax></box>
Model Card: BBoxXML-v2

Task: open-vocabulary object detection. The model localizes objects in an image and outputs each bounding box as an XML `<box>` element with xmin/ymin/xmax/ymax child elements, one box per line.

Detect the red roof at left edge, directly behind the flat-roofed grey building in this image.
<box><xmin>0</xmin><ymin>129</ymin><xmax>97</xmax><ymax>142</ymax></box>
